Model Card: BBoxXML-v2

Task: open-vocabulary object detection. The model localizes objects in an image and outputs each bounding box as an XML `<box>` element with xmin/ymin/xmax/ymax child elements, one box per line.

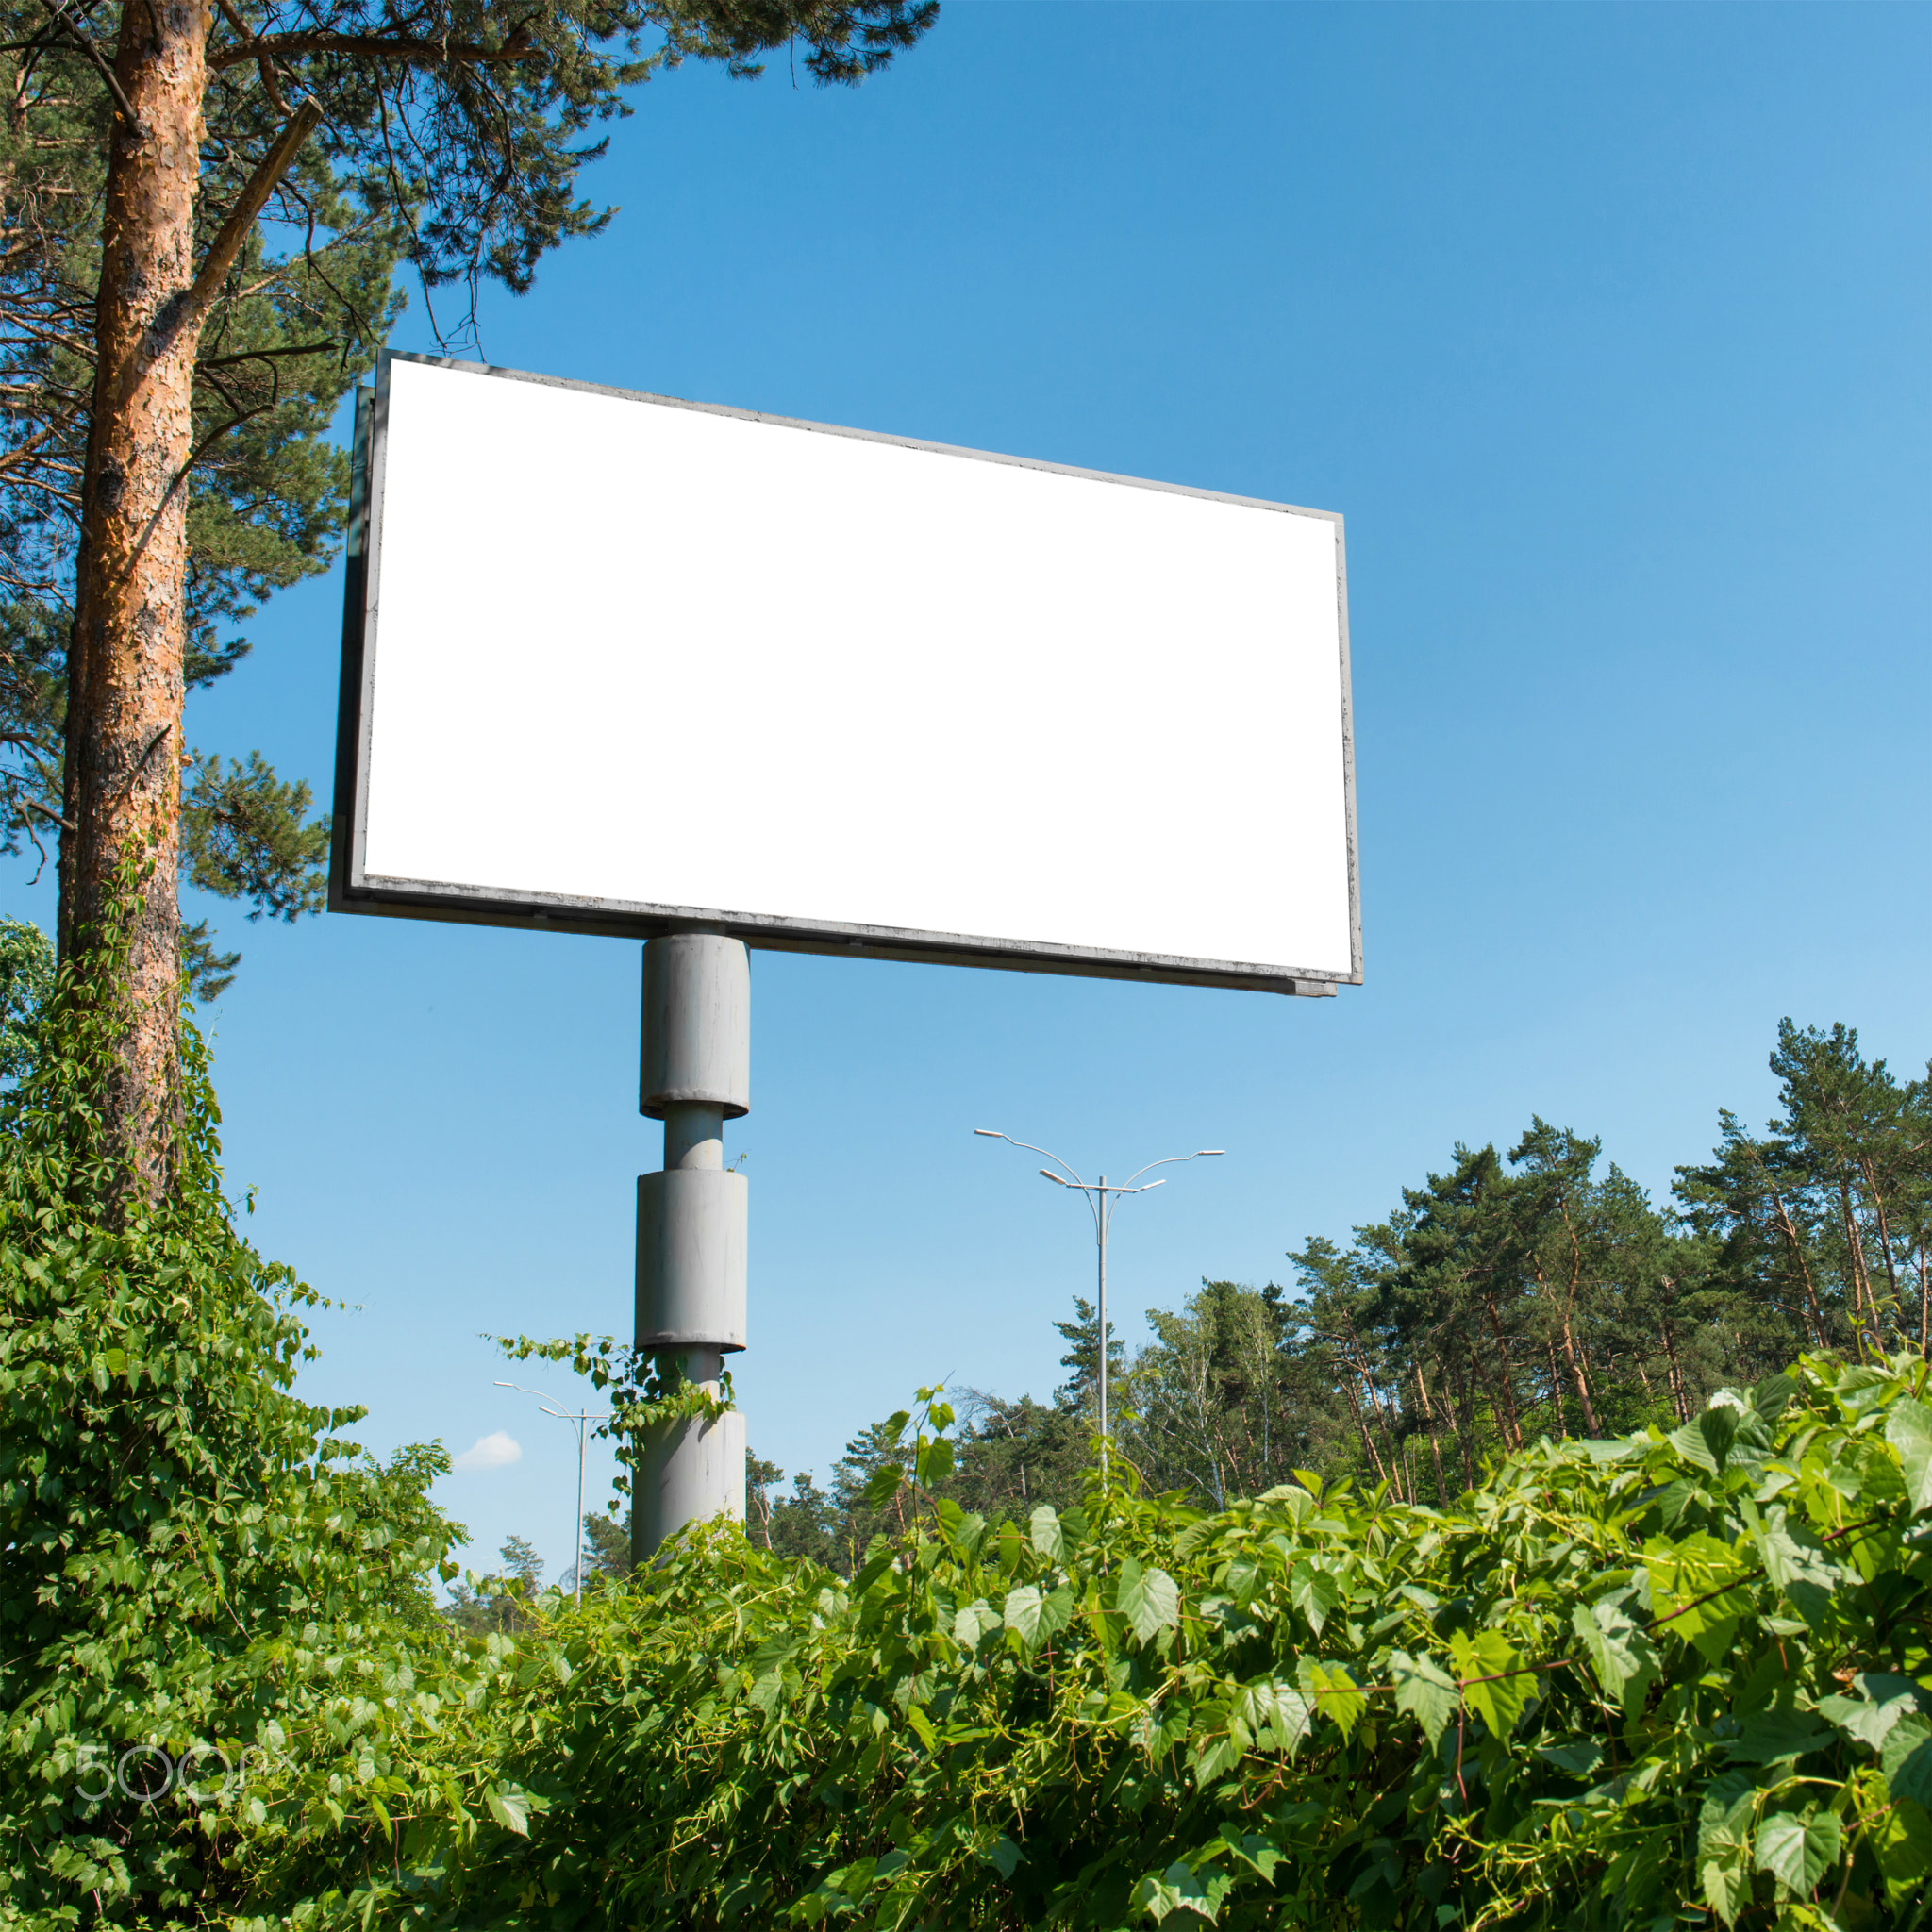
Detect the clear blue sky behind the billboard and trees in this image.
<box><xmin>0</xmin><ymin>0</ymin><xmax>1932</xmax><ymax>1574</ymax></box>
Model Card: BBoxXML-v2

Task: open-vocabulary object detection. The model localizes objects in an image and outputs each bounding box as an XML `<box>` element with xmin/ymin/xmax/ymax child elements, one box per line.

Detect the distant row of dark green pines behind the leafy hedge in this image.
<box><xmin>575</xmin><ymin>1020</ymin><xmax>1932</xmax><ymax>1574</ymax></box>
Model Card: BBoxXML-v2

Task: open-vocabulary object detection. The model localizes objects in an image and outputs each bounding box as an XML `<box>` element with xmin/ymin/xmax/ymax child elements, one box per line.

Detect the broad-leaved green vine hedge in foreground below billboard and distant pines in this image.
<box><xmin>233</xmin><ymin>1357</ymin><xmax>1932</xmax><ymax>1932</ymax></box>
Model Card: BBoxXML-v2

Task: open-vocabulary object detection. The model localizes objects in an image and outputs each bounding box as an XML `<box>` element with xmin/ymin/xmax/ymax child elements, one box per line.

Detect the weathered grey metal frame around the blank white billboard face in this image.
<box><xmin>328</xmin><ymin>352</ymin><xmax>1362</xmax><ymax>997</ymax></box>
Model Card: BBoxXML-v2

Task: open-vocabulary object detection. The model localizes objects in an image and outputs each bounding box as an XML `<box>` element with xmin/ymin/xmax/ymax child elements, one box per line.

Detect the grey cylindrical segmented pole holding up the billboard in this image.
<box><xmin>632</xmin><ymin>933</ymin><xmax>752</xmax><ymax>1561</ymax></box>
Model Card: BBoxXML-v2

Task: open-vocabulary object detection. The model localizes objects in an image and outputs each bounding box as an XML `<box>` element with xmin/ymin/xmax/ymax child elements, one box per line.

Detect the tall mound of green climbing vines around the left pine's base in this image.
<box><xmin>0</xmin><ymin>927</ymin><xmax>461</xmax><ymax>1926</ymax></box>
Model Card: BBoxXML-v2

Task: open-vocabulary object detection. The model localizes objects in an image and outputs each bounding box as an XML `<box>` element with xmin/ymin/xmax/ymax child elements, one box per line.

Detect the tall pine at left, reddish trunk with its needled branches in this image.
<box><xmin>0</xmin><ymin>0</ymin><xmax>937</xmax><ymax>1200</ymax></box>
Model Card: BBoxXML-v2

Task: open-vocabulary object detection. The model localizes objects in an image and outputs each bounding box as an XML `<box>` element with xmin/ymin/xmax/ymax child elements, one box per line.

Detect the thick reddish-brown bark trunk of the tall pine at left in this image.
<box><xmin>59</xmin><ymin>0</ymin><xmax>208</xmax><ymax>1198</ymax></box>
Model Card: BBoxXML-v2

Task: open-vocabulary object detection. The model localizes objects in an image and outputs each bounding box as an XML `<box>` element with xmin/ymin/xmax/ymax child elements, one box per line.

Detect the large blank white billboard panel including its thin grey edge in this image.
<box><xmin>332</xmin><ymin>356</ymin><xmax>1360</xmax><ymax>991</ymax></box>
